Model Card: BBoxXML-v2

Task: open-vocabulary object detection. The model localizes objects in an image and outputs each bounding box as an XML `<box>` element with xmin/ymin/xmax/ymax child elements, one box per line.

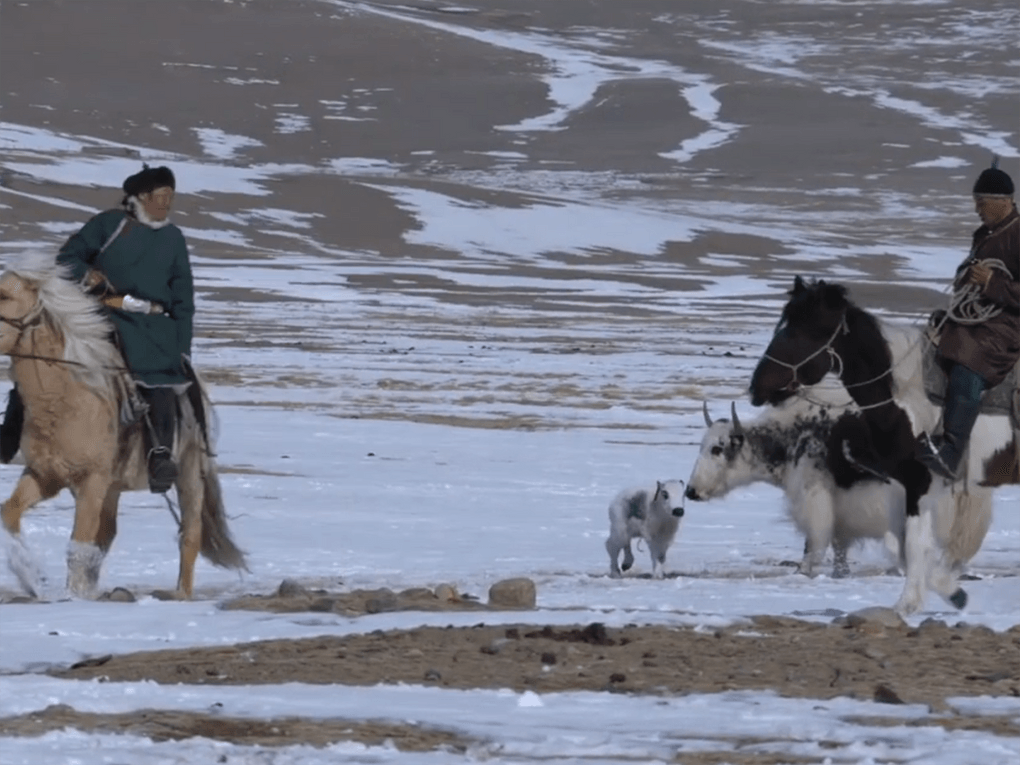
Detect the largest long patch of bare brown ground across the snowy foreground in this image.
<box><xmin>45</xmin><ymin>616</ymin><xmax>1020</xmax><ymax>710</ymax></box>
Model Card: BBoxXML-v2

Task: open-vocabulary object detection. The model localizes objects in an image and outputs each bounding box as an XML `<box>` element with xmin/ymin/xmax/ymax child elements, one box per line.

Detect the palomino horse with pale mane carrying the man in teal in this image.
<box><xmin>0</xmin><ymin>255</ymin><xmax>247</xmax><ymax>599</ymax></box>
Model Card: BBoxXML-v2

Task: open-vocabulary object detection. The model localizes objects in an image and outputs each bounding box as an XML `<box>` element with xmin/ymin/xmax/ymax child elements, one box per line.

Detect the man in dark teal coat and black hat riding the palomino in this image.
<box><xmin>0</xmin><ymin>165</ymin><xmax>197</xmax><ymax>494</ymax></box>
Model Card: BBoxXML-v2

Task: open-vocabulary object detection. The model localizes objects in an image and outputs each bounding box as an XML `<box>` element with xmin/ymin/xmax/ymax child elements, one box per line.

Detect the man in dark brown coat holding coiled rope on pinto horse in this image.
<box><xmin>919</xmin><ymin>163</ymin><xmax>1020</xmax><ymax>478</ymax></box>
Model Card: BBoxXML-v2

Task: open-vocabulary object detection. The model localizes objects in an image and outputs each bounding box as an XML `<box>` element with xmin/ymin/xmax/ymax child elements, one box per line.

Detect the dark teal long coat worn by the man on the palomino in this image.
<box><xmin>57</xmin><ymin>209</ymin><xmax>195</xmax><ymax>386</ymax></box>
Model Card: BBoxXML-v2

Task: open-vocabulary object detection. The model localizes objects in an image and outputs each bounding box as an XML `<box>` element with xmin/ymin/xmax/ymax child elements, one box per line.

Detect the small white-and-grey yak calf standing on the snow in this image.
<box><xmin>606</xmin><ymin>480</ymin><xmax>683</xmax><ymax>579</ymax></box>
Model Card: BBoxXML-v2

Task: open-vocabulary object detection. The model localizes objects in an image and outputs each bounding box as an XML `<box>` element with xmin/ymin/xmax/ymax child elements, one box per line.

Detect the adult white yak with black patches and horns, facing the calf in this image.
<box><xmin>686</xmin><ymin>397</ymin><xmax>906</xmax><ymax>578</ymax></box>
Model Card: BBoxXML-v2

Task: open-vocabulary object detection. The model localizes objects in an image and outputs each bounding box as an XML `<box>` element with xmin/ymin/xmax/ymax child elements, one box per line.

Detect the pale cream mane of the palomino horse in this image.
<box><xmin>7</xmin><ymin>252</ymin><xmax>124</xmax><ymax>393</ymax></box>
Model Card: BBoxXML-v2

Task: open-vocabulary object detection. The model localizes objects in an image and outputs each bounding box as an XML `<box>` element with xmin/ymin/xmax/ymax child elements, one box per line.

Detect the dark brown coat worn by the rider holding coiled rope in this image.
<box><xmin>938</xmin><ymin>206</ymin><xmax>1020</xmax><ymax>388</ymax></box>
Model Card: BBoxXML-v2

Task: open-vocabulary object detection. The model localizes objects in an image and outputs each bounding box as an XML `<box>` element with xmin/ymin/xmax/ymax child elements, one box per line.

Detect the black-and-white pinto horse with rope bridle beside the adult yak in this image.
<box><xmin>751</xmin><ymin>276</ymin><xmax>1016</xmax><ymax>613</ymax></box>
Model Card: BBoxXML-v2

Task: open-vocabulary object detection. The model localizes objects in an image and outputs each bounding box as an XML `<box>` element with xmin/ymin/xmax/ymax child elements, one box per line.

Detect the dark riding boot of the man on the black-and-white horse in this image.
<box><xmin>917</xmin><ymin>364</ymin><xmax>985</xmax><ymax>479</ymax></box>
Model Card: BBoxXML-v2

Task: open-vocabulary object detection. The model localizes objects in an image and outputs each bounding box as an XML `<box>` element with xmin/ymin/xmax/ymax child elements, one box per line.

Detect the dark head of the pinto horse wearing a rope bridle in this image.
<box><xmin>751</xmin><ymin>276</ymin><xmax>850</xmax><ymax>406</ymax></box>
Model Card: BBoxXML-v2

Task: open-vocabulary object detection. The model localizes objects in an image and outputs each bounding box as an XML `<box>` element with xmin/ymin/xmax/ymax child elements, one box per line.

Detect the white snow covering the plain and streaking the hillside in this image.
<box><xmin>0</xmin><ymin>3</ymin><xmax>1020</xmax><ymax>765</ymax></box>
